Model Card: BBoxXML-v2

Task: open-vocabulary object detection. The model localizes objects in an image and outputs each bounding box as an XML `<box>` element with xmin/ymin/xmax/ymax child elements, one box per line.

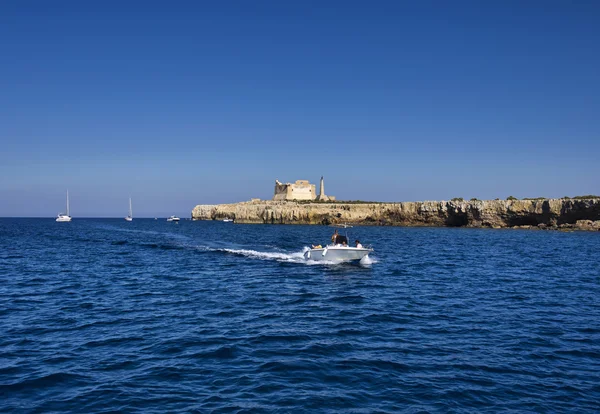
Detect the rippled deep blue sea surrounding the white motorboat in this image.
<box><xmin>0</xmin><ymin>219</ymin><xmax>600</xmax><ymax>413</ymax></box>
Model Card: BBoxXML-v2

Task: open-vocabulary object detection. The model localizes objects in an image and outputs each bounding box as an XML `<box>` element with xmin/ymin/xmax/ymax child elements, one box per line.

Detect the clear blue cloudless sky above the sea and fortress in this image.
<box><xmin>0</xmin><ymin>0</ymin><xmax>600</xmax><ymax>217</ymax></box>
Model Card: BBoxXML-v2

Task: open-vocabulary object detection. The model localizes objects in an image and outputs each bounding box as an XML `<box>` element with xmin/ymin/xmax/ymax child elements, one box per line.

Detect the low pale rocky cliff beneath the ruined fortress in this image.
<box><xmin>192</xmin><ymin>199</ymin><xmax>600</xmax><ymax>230</ymax></box>
